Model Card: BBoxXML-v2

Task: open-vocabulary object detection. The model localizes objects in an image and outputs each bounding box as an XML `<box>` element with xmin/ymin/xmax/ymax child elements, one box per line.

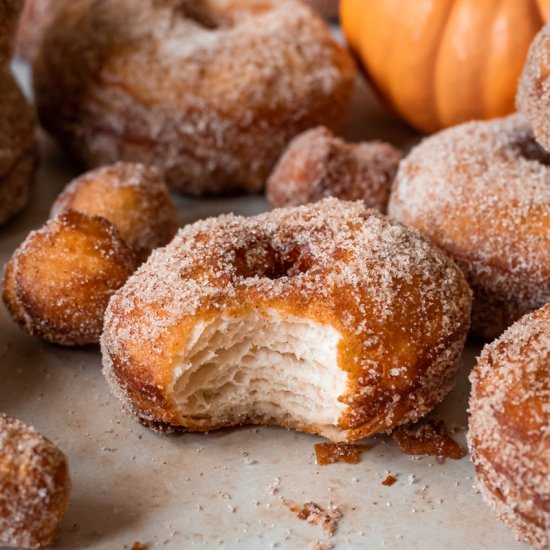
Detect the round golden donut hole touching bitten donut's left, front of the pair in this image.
<box><xmin>3</xmin><ymin>210</ymin><xmax>137</xmax><ymax>346</ymax></box>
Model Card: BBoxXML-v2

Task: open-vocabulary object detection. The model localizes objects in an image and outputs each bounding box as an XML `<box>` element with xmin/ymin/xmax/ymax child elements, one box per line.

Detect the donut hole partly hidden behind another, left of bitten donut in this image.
<box><xmin>51</xmin><ymin>162</ymin><xmax>178</xmax><ymax>261</ymax></box>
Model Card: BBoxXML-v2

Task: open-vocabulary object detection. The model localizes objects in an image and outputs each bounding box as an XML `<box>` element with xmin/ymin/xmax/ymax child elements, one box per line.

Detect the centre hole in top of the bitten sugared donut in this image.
<box><xmin>234</xmin><ymin>239</ymin><xmax>311</xmax><ymax>280</ymax></box>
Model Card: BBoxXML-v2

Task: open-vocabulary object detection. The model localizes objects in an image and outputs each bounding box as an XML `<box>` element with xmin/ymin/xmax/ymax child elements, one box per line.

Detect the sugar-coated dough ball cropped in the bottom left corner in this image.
<box><xmin>0</xmin><ymin>414</ymin><xmax>71</xmax><ymax>548</ymax></box>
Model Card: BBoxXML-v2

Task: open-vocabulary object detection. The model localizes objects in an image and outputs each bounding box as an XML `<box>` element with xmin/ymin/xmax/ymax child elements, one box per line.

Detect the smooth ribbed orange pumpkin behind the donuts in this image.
<box><xmin>340</xmin><ymin>0</ymin><xmax>550</xmax><ymax>132</ymax></box>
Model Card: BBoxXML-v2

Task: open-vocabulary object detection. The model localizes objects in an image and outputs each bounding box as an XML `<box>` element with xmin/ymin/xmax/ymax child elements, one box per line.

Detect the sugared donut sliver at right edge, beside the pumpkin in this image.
<box><xmin>516</xmin><ymin>23</ymin><xmax>550</xmax><ymax>150</ymax></box>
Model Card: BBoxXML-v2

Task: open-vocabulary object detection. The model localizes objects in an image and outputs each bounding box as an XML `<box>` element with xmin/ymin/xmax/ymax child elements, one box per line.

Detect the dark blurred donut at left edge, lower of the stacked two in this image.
<box><xmin>0</xmin><ymin>69</ymin><xmax>37</xmax><ymax>229</ymax></box>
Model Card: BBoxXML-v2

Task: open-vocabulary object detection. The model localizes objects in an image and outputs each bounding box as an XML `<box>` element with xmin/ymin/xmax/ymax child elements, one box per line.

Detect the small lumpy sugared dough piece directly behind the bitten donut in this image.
<box><xmin>266</xmin><ymin>127</ymin><xmax>402</xmax><ymax>212</ymax></box>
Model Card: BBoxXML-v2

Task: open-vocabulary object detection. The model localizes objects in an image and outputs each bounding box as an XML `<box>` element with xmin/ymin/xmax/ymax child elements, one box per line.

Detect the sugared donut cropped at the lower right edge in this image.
<box><xmin>468</xmin><ymin>304</ymin><xmax>550</xmax><ymax>550</ymax></box>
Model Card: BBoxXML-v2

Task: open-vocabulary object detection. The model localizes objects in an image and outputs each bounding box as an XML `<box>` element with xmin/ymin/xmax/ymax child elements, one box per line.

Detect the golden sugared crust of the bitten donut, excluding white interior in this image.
<box><xmin>102</xmin><ymin>199</ymin><xmax>471</xmax><ymax>440</ymax></box>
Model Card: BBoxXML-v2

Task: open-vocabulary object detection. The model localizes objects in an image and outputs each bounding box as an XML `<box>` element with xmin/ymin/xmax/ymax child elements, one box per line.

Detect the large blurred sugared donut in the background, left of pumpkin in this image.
<box><xmin>33</xmin><ymin>0</ymin><xmax>355</xmax><ymax>194</ymax></box>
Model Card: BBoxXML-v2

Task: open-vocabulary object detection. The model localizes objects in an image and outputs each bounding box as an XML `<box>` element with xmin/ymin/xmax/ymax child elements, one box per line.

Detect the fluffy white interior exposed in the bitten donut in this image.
<box><xmin>174</xmin><ymin>310</ymin><xmax>347</xmax><ymax>437</ymax></box>
